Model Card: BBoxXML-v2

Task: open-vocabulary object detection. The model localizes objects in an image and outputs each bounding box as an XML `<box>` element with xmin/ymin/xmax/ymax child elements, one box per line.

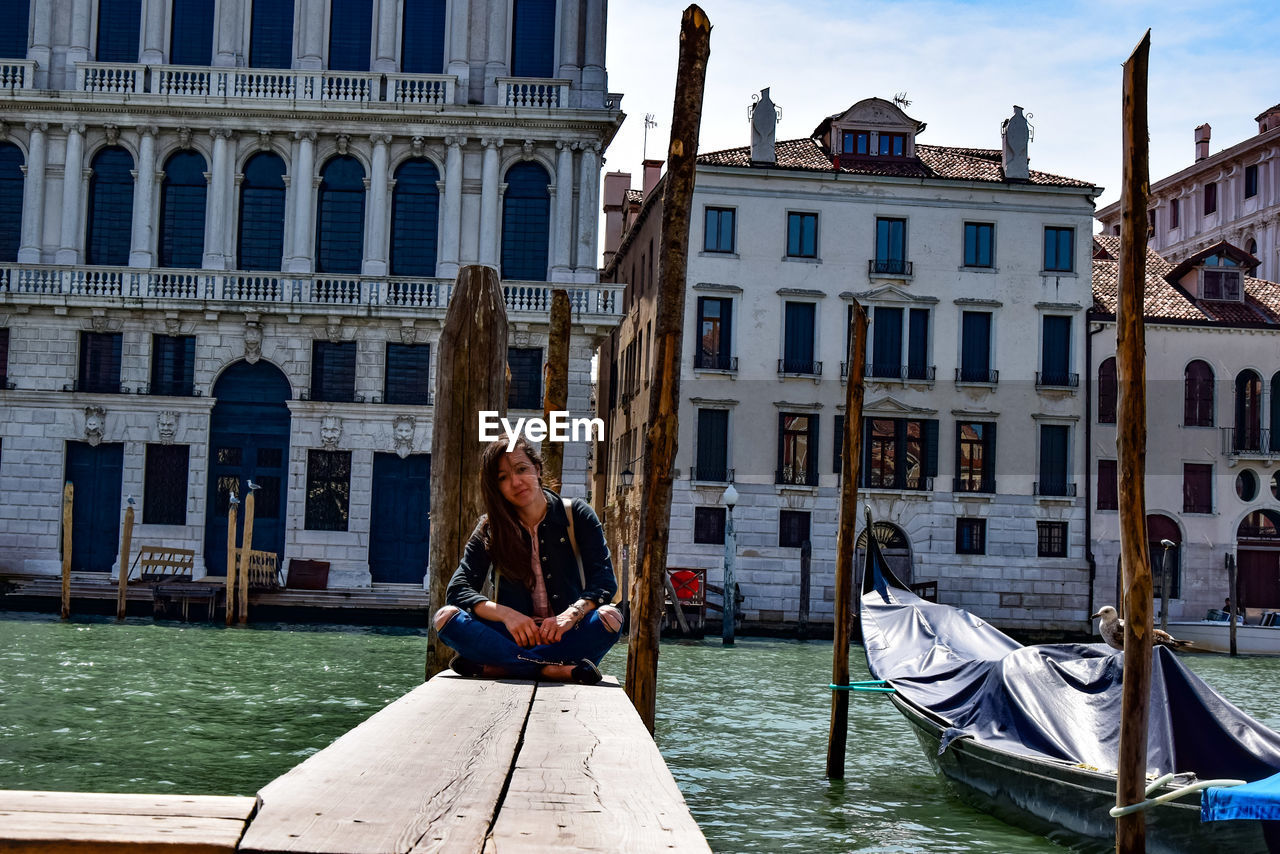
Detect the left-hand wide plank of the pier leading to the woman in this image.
<box><xmin>241</xmin><ymin>672</ymin><xmax>534</xmax><ymax>854</ymax></box>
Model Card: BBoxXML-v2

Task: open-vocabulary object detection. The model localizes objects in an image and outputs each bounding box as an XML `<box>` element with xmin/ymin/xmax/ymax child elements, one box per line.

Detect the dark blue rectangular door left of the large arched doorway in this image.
<box><xmin>67</xmin><ymin>442</ymin><xmax>124</xmax><ymax>572</ymax></box>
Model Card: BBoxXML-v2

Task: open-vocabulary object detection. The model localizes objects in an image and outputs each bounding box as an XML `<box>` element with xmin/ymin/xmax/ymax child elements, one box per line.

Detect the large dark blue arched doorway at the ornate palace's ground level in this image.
<box><xmin>205</xmin><ymin>361</ymin><xmax>292</xmax><ymax>575</ymax></box>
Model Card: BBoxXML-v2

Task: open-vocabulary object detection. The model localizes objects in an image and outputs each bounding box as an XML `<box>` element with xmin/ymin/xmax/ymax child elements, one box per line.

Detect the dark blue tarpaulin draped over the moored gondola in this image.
<box><xmin>861</xmin><ymin>536</ymin><xmax>1280</xmax><ymax>781</ymax></box>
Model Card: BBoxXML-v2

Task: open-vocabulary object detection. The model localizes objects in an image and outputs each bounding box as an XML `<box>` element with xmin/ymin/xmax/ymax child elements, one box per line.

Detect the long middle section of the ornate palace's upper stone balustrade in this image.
<box><xmin>73</xmin><ymin>63</ymin><xmax>455</xmax><ymax>105</ymax></box>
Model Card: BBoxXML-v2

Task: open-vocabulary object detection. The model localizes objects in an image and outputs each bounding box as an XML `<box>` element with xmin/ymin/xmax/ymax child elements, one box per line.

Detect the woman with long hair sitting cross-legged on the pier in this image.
<box><xmin>434</xmin><ymin>437</ymin><xmax>622</xmax><ymax>685</ymax></box>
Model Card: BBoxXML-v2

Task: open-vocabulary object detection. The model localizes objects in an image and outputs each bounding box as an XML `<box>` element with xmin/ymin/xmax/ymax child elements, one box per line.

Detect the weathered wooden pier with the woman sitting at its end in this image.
<box><xmin>0</xmin><ymin>672</ymin><xmax>710</xmax><ymax>854</ymax></box>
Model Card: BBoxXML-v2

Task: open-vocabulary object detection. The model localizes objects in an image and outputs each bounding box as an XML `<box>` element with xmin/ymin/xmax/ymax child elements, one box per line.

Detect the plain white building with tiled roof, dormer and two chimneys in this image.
<box><xmin>602</xmin><ymin>99</ymin><xmax>1100</xmax><ymax>630</ymax></box>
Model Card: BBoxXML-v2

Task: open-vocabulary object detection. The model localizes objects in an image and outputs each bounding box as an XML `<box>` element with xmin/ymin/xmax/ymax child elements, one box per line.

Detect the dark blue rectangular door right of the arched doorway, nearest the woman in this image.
<box><xmin>369</xmin><ymin>453</ymin><xmax>431</xmax><ymax>584</ymax></box>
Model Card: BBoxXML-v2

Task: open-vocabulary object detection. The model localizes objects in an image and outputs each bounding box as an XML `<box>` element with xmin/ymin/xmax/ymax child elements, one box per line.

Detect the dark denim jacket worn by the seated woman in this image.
<box><xmin>444</xmin><ymin>489</ymin><xmax>618</xmax><ymax>615</ymax></box>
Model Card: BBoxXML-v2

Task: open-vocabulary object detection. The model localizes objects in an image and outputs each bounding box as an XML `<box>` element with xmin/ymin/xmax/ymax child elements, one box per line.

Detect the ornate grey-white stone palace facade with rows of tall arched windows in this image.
<box><xmin>0</xmin><ymin>0</ymin><xmax>622</xmax><ymax>586</ymax></box>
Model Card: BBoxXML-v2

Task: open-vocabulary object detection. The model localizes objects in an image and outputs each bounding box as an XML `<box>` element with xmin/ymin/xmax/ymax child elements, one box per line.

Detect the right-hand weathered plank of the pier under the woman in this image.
<box><xmin>485</xmin><ymin>680</ymin><xmax>710</xmax><ymax>854</ymax></box>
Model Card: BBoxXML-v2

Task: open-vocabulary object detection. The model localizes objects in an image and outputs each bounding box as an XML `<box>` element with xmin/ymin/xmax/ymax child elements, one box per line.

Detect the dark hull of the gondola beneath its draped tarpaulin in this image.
<box><xmin>890</xmin><ymin>694</ymin><xmax>1280</xmax><ymax>854</ymax></box>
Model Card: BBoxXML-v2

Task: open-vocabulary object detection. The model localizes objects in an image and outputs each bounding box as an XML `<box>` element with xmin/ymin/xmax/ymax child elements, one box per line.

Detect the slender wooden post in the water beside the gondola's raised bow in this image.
<box><xmin>827</xmin><ymin>301</ymin><xmax>872</xmax><ymax>780</ymax></box>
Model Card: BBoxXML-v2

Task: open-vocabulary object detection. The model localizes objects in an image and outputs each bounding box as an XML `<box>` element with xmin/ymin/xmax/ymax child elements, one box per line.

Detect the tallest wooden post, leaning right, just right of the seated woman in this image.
<box><xmin>627</xmin><ymin>5</ymin><xmax>711</xmax><ymax>732</ymax></box>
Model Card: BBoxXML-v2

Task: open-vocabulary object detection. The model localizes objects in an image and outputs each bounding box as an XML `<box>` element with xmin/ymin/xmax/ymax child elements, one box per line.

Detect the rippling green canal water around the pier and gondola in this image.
<box><xmin>0</xmin><ymin>613</ymin><xmax>1280</xmax><ymax>853</ymax></box>
